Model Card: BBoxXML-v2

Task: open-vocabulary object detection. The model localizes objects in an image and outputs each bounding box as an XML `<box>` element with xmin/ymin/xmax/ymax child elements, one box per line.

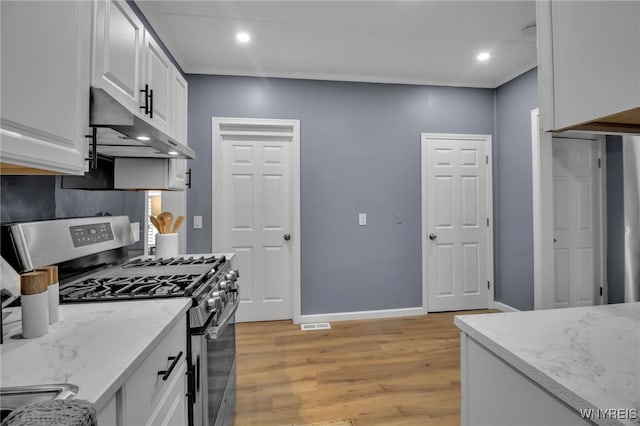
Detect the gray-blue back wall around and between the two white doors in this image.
<box><xmin>187</xmin><ymin>75</ymin><xmax>496</xmax><ymax>314</ymax></box>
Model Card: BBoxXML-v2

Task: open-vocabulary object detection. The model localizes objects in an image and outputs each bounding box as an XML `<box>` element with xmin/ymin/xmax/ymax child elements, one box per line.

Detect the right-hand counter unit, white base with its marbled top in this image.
<box><xmin>454</xmin><ymin>303</ymin><xmax>640</xmax><ymax>426</ymax></box>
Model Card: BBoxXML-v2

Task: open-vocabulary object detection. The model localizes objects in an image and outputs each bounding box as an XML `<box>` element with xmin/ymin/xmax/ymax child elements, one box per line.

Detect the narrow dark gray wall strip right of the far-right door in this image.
<box><xmin>606</xmin><ymin>136</ymin><xmax>624</xmax><ymax>303</ymax></box>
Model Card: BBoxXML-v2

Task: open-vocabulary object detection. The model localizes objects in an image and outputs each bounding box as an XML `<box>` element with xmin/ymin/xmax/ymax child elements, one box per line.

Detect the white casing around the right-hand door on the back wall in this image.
<box><xmin>420</xmin><ymin>133</ymin><xmax>496</xmax><ymax>314</ymax></box>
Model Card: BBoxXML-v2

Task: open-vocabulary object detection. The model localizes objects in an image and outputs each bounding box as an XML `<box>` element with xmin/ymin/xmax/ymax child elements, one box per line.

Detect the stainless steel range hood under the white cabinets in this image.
<box><xmin>89</xmin><ymin>87</ymin><xmax>195</xmax><ymax>159</ymax></box>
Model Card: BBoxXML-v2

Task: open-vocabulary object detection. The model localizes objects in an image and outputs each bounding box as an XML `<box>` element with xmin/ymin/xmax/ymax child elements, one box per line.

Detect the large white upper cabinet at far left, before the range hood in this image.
<box><xmin>0</xmin><ymin>1</ymin><xmax>92</xmax><ymax>174</ymax></box>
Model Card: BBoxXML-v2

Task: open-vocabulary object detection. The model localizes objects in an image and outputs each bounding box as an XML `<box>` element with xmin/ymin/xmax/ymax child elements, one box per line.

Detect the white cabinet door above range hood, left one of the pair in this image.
<box><xmin>91</xmin><ymin>0</ymin><xmax>144</xmax><ymax>112</ymax></box>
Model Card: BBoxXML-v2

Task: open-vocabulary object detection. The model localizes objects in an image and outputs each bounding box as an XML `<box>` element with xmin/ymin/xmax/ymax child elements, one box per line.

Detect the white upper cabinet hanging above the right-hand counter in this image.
<box><xmin>536</xmin><ymin>0</ymin><xmax>640</xmax><ymax>133</ymax></box>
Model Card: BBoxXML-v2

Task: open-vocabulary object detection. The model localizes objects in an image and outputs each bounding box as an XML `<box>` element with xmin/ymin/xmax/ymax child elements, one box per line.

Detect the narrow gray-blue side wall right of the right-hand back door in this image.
<box><xmin>493</xmin><ymin>69</ymin><xmax>538</xmax><ymax>310</ymax></box>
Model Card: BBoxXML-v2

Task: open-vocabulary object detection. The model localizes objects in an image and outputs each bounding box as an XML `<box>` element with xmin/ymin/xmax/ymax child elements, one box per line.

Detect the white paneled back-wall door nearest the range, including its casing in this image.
<box><xmin>213</xmin><ymin>119</ymin><xmax>300</xmax><ymax>321</ymax></box>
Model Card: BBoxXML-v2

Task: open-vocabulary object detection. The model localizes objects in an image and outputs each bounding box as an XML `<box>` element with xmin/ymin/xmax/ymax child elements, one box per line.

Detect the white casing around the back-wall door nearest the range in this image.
<box><xmin>211</xmin><ymin>117</ymin><xmax>301</xmax><ymax>324</ymax></box>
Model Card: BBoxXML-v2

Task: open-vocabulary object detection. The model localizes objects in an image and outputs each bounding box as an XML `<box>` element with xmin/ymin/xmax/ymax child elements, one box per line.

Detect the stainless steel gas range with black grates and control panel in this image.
<box><xmin>2</xmin><ymin>216</ymin><xmax>239</xmax><ymax>426</ymax></box>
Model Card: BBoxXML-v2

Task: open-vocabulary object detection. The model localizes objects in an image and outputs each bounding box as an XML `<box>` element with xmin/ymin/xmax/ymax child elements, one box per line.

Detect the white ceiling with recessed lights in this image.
<box><xmin>136</xmin><ymin>0</ymin><xmax>537</xmax><ymax>88</ymax></box>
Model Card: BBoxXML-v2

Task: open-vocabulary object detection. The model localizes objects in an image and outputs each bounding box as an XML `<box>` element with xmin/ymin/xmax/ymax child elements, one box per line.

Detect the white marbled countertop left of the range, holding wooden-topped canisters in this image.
<box><xmin>0</xmin><ymin>298</ymin><xmax>191</xmax><ymax>412</ymax></box>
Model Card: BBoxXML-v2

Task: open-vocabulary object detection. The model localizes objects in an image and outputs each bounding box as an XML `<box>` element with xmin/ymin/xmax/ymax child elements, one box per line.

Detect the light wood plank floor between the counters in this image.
<box><xmin>234</xmin><ymin>311</ymin><xmax>496</xmax><ymax>426</ymax></box>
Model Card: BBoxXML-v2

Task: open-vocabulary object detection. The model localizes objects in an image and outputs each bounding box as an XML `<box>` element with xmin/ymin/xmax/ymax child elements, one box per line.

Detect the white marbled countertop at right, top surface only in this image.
<box><xmin>454</xmin><ymin>302</ymin><xmax>640</xmax><ymax>425</ymax></box>
